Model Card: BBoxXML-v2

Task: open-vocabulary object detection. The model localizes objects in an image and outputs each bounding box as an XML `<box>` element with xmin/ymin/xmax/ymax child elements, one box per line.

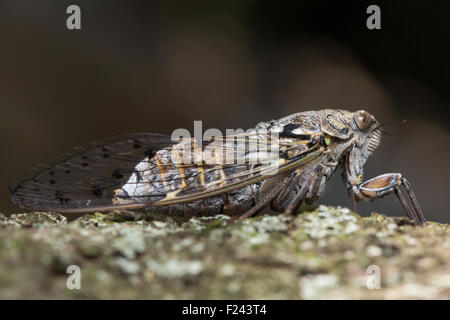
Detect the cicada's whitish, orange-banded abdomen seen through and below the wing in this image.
<box><xmin>113</xmin><ymin>141</ymin><xmax>260</xmax><ymax>216</ymax></box>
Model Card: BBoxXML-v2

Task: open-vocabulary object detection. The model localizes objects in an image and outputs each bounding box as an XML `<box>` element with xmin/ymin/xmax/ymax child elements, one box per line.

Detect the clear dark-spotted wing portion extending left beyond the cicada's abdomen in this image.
<box><xmin>9</xmin><ymin>133</ymin><xmax>178</xmax><ymax>212</ymax></box>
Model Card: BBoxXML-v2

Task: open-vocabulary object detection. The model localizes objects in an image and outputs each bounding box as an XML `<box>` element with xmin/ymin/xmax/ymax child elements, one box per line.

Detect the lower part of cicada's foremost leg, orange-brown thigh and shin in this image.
<box><xmin>351</xmin><ymin>173</ymin><xmax>426</xmax><ymax>225</ymax></box>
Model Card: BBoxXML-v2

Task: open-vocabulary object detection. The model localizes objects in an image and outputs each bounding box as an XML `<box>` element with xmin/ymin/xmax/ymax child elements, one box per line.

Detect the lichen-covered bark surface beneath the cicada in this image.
<box><xmin>0</xmin><ymin>206</ymin><xmax>450</xmax><ymax>299</ymax></box>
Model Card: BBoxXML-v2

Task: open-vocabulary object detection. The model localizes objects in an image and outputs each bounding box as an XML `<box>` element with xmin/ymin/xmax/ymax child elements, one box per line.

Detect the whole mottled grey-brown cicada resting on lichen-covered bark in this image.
<box><xmin>9</xmin><ymin>109</ymin><xmax>425</xmax><ymax>224</ymax></box>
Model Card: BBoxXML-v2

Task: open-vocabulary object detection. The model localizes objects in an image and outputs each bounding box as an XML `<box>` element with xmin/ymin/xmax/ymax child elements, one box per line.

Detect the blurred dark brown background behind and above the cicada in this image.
<box><xmin>0</xmin><ymin>0</ymin><xmax>450</xmax><ymax>223</ymax></box>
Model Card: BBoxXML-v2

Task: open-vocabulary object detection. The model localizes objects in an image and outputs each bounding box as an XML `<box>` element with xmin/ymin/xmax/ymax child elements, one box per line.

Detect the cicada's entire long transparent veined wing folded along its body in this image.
<box><xmin>7</xmin><ymin>132</ymin><xmax>323</xmax><ymax>212</ymax></box>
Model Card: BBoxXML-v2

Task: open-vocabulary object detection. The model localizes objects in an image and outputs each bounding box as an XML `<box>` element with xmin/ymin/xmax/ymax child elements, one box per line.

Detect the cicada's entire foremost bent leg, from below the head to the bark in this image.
<box><xmin>346</xmin><ymin>149</ymin><xmax>426</xmax><ymax>225</ymax></box>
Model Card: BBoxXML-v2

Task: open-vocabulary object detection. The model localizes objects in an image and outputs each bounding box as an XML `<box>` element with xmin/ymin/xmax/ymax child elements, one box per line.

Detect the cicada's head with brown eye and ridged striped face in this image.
<box><xmin>352</xmin><ymin>110</ymin><xmax>383</xmax><ymax>160</ymax></box>
